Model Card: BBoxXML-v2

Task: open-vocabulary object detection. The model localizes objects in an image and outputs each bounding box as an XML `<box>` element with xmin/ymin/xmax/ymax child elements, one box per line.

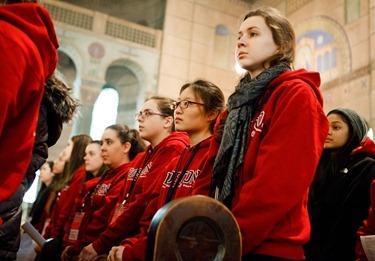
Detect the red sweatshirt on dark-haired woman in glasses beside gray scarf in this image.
<box><xmin>121</xmin><ymin>137</ymin><xmax>211</xmax><ymax>260</ymax></box>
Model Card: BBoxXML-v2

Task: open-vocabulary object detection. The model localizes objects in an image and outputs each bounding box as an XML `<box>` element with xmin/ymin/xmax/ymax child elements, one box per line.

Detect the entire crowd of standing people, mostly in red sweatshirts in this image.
<box><xmin>0</xmin><ymin>0</ymin><xmax>375</xmax><ymax>261</ymax></box>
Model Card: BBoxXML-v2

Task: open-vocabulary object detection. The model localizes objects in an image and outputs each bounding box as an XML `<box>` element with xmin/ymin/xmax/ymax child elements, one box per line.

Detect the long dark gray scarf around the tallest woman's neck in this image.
<box><xmin>212</xmin><ymin>62</ymin><xmax>290</xmax><ymax>207</ymax></box>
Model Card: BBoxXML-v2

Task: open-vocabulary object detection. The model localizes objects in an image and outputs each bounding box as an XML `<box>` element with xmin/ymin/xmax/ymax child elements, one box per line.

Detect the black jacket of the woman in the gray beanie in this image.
<box><xmin>305</xmin><ymin>139</ymin><xmax>375</xmax><ymax>261</ymax></box>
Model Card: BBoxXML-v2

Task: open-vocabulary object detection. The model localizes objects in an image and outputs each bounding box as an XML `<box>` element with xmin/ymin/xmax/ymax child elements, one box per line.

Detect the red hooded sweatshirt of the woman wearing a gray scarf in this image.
<box><xmin>231</xmin><ymin>69</ymin><xmax>328</xmax><ymax>260</ymax></box>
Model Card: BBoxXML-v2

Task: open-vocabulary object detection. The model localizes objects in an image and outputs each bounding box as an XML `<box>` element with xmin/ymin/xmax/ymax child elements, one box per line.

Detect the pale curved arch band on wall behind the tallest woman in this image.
<box><xmin>295</xmin><ymin>15</ymin><xmax>352</xmax><ymax>81</ymax></box>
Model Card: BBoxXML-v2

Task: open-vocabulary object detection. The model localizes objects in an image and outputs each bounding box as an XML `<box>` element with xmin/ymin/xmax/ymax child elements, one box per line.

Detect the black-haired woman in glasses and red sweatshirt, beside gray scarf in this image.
<box><xmin>108</xmin><ymin>80</ymin><xmax>224</xmax><ymax>260</ymax></box>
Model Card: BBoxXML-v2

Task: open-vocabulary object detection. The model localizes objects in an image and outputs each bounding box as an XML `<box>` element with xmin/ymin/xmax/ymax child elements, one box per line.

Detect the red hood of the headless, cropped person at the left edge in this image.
<box><xmin>0</xmin><ymin>3</ymin><xmax>59</xmax><ymax>79</ymax></box>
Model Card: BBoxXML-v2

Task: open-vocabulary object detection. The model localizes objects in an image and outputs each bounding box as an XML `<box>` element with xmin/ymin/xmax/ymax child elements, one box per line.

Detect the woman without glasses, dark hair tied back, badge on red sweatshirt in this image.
<box><xmin>62</xmin><ymin>124</ymin><xmax>145</xmax><ymax>260</ymax></box>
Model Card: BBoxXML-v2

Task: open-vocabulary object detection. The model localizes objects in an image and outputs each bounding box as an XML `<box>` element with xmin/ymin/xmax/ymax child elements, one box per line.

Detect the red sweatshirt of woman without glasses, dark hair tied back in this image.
<box><xmin>68</xmin><ymin>161</ymin><xmax>135</xmax><ymax>256</ymax></box>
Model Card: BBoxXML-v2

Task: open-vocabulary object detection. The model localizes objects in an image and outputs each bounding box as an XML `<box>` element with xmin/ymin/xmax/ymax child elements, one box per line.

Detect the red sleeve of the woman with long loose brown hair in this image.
<box><xmin>52</xmin><ymin>166</ymin><xmax>86</xmax><ymax>238</ymax></box>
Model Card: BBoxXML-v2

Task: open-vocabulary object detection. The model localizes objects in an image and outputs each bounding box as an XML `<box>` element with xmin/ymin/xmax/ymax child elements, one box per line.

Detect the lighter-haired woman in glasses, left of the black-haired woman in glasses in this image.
<box><xmin>80</xmin><ymin>96</ymin><xmax>189</xmax><ymax>260</ymax></box>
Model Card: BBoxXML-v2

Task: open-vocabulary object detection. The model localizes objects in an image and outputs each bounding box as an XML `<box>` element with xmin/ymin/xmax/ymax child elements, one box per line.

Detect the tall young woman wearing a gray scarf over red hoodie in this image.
<box><xmin>212</xmin><ymin>7</ymin><xmax>328</xmax><ymax>261</ymax></box>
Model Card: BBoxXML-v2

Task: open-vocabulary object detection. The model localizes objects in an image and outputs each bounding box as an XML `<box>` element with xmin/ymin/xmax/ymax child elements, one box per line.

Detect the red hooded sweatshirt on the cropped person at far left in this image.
<box><xmin>0</xmin><ymin>3</ymin><xmax>58</xmax><ymax>202</ymax></box>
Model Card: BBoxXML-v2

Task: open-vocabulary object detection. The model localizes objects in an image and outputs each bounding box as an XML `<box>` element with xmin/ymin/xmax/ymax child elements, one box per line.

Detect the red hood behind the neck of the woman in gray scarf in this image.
<box><xmin>269</xmin><ymin>69</ymin><xmax>323</xmax><ymax>106</ymax></box>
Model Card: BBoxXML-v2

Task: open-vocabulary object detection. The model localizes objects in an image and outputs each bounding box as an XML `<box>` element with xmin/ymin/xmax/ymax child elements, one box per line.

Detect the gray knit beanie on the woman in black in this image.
<box><xmin>327</xmin><ymin>108</ymin><xmax>367</xmax><ymax>143</ymax></box>
